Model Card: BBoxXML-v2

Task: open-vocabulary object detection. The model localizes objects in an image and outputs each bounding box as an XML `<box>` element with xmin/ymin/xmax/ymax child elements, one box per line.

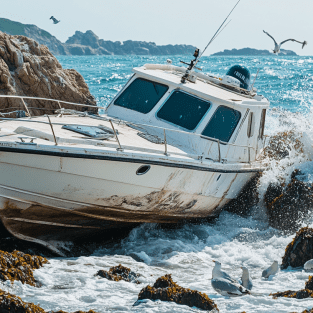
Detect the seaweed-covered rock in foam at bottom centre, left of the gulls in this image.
<box><xmin>138</xmin><ymin>275</ymin><xmax>219</xmax><ymax>312</ymax></box>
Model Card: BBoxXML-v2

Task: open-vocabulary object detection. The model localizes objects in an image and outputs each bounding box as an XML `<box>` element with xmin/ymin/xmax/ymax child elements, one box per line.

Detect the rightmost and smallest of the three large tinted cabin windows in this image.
<box><xmin>202</xmin><ymin>106</ymin><xmax>241</xmax><ymax>142</ymax></box>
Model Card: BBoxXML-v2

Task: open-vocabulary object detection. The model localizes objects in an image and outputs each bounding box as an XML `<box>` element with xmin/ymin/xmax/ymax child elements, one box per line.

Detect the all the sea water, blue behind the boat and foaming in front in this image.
<box><xmin>0</xmin><ymin>56</ymin><xmax>313</xmax><ymax>313</ymax></box>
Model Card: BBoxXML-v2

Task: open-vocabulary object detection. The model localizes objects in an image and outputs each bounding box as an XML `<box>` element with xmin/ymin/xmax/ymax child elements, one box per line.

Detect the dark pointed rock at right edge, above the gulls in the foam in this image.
<box><xmin>281</xmin><ymin>227</ymin><xmax>313</xmax><ymax>269</ymax></box>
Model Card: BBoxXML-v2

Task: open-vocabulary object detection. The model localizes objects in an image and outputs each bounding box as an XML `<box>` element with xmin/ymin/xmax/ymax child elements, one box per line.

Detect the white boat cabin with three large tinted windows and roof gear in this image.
<box><xmin>106</xmin><ymin>64</ymin><xmax>269</xmax><ymax>162</ymax></box>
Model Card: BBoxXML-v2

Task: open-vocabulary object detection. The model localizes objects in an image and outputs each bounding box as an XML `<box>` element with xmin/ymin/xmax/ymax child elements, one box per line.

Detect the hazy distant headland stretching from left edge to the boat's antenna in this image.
<box><xmin>0</xmin><ymin>18</ymin><xmax>196</xmax><ymax>55</ymax></box>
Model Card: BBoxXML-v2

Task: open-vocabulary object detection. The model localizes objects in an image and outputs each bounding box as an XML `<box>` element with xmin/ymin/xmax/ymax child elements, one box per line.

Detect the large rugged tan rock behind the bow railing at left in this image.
<box><xmin>0</xmin><ymin>31</ymin><xmax>96</xmax><ymax>115</ymax></box>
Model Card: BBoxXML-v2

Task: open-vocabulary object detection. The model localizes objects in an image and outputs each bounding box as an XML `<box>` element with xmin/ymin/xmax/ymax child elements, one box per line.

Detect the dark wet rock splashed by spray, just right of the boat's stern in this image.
<box><xmin>264</xmin><ymin>170</ymin><xmax>313</xmax><ymax>233</ymax></box>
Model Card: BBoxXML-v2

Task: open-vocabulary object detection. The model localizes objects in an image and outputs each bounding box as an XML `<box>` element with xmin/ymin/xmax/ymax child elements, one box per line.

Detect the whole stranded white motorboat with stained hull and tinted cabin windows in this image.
<box><xmin>0</xmin><ymin>53</ymin><xmax>269</xmax><ymax>251</ymax></box>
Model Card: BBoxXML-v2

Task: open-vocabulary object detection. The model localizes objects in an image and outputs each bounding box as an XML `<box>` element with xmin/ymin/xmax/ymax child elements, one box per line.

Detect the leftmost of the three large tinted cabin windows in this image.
<box><xmin>114</xmin><ymin>78</ymin><xmax>168</xmax><ymax>114</ymax></box>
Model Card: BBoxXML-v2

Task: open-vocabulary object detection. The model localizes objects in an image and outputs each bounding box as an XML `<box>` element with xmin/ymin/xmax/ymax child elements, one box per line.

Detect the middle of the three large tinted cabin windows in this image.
<box><xmin>157</xmin><ymin>91</ymin><xmax>211</xmax><ymax>130</ymax></box>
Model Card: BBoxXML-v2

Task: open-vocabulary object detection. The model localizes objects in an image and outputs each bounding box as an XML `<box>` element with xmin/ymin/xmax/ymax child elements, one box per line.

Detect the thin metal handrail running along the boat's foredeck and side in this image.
<box><xmin>0</xmin><ymin>95</ymin><xmax>256</xmax><ymax>163</ymax></box>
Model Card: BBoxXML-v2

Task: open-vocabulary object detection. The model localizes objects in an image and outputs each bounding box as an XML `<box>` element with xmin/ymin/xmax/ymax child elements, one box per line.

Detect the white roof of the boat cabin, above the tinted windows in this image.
<box><xmin>133</xmin><ymin>66</ymin><xmax>269</xmax><ymax>106</ymax></box>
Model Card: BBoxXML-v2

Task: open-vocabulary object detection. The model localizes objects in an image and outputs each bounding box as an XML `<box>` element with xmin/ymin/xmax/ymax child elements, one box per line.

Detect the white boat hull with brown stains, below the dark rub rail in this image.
<box><xmin>0</xmin><ymin>151</ymin><xmax>255</xmax><ymax>254</ymax></box>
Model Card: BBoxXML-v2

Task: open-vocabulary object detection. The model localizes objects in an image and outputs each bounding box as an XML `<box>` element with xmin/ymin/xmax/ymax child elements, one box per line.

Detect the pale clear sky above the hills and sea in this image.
<box><xmin>0</xmin><ymin>0</ymin><xmax>313</xmax><ymax>55</ymax></box>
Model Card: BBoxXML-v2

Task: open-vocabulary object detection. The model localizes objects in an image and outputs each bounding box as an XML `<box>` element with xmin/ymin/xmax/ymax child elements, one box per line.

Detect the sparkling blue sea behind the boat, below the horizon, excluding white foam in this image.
<box><xmin>58</xmin><ymin>55</ymin><xmax>313</xmax><ymax>112</ymax></box>
